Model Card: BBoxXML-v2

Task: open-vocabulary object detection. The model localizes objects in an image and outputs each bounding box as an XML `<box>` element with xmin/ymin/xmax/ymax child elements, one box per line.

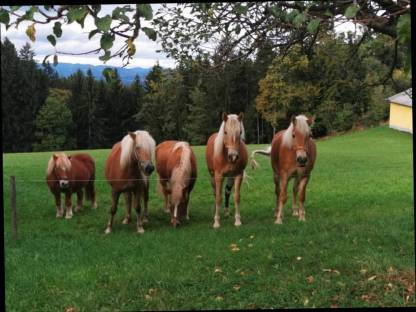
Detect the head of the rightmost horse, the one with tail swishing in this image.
<box><xmin>288</xmin><ymin>115</ymin><xmax>314</xmax><ymax>167</ymax></box>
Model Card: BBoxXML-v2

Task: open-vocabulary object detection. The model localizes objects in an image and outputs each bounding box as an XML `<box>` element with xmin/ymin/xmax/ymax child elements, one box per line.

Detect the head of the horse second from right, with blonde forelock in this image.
<box><xmin>219</xmin><ymin>113</ymin><xmax>244</xmax><ymax>163</ymax></box>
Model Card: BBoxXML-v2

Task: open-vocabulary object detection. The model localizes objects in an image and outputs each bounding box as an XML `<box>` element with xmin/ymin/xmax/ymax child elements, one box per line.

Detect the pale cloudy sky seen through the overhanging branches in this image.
<box><xmin>0</xmin><ymin>4</ymin><xmax>360</xmax><ymax>68</ymax></box>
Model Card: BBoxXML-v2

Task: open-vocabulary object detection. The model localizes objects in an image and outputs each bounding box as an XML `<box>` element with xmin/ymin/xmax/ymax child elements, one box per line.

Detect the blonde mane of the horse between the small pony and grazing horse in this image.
<box><xmin>120</xmin><ymin>130</ymin><xmax>156</xmax><ymax>168</ymax></box>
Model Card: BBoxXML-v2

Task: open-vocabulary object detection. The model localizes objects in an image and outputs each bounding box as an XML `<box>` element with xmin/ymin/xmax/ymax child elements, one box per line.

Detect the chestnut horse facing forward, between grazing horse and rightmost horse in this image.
<box><xmin>205</xmin><ymin>113</ymin><xmax>248</xmax><ymax>229</ymax></box>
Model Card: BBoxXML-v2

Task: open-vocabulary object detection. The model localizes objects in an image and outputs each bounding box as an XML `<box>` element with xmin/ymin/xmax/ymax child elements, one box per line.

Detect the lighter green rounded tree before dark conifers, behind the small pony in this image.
<box><xmin>33</xmin><ymin>89</ymin><xmax>74</xmax><ymax>151</ymax></box>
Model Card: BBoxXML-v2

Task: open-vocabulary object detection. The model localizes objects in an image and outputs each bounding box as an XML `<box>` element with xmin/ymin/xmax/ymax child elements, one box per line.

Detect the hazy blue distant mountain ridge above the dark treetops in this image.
<box><xmin>38</xmin><ymin>63</ymin><xmax>151</xmax><ymax>85</ymax></box>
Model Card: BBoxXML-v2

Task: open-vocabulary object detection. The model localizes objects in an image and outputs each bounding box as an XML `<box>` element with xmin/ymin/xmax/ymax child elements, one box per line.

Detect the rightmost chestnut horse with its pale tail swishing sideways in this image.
<box><xmin>251</xmin><ymin>115</ymin><xmax>317</xmax><ymax>224</ymax></box>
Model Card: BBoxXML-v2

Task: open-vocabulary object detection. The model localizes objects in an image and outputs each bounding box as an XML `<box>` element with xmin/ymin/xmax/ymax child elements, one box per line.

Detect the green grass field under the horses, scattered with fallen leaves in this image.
<box><xmin>3</xmin><ymin>127</ymin><xmax>415</xmax><ymax>311</ymax></box>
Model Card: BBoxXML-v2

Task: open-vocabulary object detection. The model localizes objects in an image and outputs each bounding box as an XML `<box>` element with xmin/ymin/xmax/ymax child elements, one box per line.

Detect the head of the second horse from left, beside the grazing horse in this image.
<box><xmin>128</xmin><ymin>131</ymin><xmax>155</xmax><ymax>176</ymax></box>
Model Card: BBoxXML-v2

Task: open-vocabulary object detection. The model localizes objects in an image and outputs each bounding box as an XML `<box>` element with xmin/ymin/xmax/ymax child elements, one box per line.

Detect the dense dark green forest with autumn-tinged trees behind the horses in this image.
<box><xmin>1</xmin><ymin>31</ymin><xmax>411</xmax><ymax>152</ymax></box>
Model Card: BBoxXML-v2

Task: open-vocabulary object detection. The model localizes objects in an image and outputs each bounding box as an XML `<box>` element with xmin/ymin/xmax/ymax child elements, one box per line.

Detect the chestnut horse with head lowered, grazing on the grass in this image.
<box><xmin>156</xmin><ymin>140</ymin><xmax>197</xmax><ymax>228</ymax></box>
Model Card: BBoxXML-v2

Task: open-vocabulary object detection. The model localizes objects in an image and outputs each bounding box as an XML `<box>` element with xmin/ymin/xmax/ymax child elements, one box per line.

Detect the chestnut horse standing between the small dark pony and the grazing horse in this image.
<box><xmin>105</xmin><ymin>130</ymin><xmax>156</xmax><ymax>234</ymax></box>
